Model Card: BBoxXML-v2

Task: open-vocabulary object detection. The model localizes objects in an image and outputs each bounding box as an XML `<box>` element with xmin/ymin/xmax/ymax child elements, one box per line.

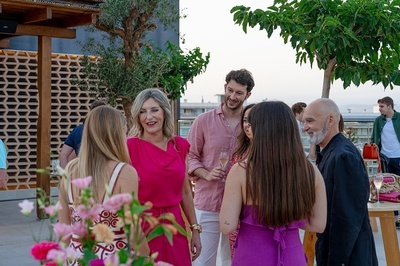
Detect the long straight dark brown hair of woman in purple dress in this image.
<box><xmin>246</xmin><ymin>101</ymin><xmax>315</xmax><ymax>227</ymax></box>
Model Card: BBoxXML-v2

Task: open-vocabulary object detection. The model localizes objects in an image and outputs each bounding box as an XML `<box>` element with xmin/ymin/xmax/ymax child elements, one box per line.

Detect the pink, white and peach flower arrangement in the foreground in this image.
<box><xmin>19</xmin><ymin>168</ymin><xmax>187</xmax><ymax>266</ymax></box>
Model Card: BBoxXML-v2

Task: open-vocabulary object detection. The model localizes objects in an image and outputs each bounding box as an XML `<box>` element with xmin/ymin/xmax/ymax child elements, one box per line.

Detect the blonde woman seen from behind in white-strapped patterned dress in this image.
<box><xmin>58</xmin><ymin>106</ymin><xmax>150</xmax><ymax>259</ymax></box>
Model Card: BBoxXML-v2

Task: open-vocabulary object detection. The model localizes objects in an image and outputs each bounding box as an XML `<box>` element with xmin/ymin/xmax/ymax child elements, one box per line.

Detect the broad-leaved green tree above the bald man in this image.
<box><xmin>231</xmin><ymin>0</ymin><xmax>400</xmax><ymax>98</ymax></box>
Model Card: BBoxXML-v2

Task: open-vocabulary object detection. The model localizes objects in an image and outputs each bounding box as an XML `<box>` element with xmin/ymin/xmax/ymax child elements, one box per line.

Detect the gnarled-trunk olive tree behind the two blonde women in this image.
<box><xmin>78</xmin><ymin>0</ymin><xmax>209</xmax><ymax>128</ymax></box>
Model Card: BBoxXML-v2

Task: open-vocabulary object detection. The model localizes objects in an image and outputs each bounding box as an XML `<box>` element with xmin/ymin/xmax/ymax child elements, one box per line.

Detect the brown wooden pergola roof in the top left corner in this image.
<box><xmin>0</xmin><ymin>0</ymin><xmax>104</xmax><ymax>41</ymax></box>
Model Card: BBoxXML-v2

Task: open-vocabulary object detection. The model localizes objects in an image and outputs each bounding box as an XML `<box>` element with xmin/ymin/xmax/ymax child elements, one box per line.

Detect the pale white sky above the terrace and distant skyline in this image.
<box><xmin>180</xmin><ymin>0</ymin><xmax>400</xmax><ymax>112</ymax></box>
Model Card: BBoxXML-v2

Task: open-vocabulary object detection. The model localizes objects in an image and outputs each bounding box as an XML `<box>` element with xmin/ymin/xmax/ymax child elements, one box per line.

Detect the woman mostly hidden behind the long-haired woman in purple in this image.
<box><xmin>229</xmin><ymin>103</ymin><xmax>255</xmax><ymax>258</ymax></box>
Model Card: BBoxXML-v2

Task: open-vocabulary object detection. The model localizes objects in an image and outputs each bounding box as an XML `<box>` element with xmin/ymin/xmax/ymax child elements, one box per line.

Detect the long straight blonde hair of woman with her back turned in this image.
<box><xmin>66</xmin><ymin>106</ymin><xmax>130</xmax><ymax>202</ymax></box>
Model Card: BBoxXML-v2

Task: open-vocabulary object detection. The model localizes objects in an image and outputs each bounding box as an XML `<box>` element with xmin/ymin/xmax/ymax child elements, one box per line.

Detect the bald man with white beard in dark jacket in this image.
<box><xmin>303</xmin><ymin>98</ymin><xmax>378</xmax><ymax>266</ymax></box>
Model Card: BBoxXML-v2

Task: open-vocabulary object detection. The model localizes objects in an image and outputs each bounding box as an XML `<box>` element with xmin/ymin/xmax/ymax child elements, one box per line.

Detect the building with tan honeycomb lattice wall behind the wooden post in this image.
<box><xmin>0</xmin><ymin>0</ymin><xmax>179</xmax><ymax>201</ymax></box>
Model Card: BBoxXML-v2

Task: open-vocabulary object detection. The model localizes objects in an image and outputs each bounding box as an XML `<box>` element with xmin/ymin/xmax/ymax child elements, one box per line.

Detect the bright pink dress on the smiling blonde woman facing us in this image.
<box><xmin>127</xmin><ymin>136</ymin><xmax>192</xmax><ymax>266</ymax></box>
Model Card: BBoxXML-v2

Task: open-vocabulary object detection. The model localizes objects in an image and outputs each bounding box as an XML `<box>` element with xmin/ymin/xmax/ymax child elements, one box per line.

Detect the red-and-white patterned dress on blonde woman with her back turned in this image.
<box><xmin>68</xmin><ymin>163</ymin><xmax>127</xmax><ymax>265</ymax></box>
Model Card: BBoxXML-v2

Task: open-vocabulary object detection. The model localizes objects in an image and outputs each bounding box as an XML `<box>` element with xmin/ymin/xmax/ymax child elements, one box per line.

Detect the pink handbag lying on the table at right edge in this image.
<box><xmin>370</xmin><ymin>173</ymin><xmax>400</xmax><ymax>202</ymax></box>
